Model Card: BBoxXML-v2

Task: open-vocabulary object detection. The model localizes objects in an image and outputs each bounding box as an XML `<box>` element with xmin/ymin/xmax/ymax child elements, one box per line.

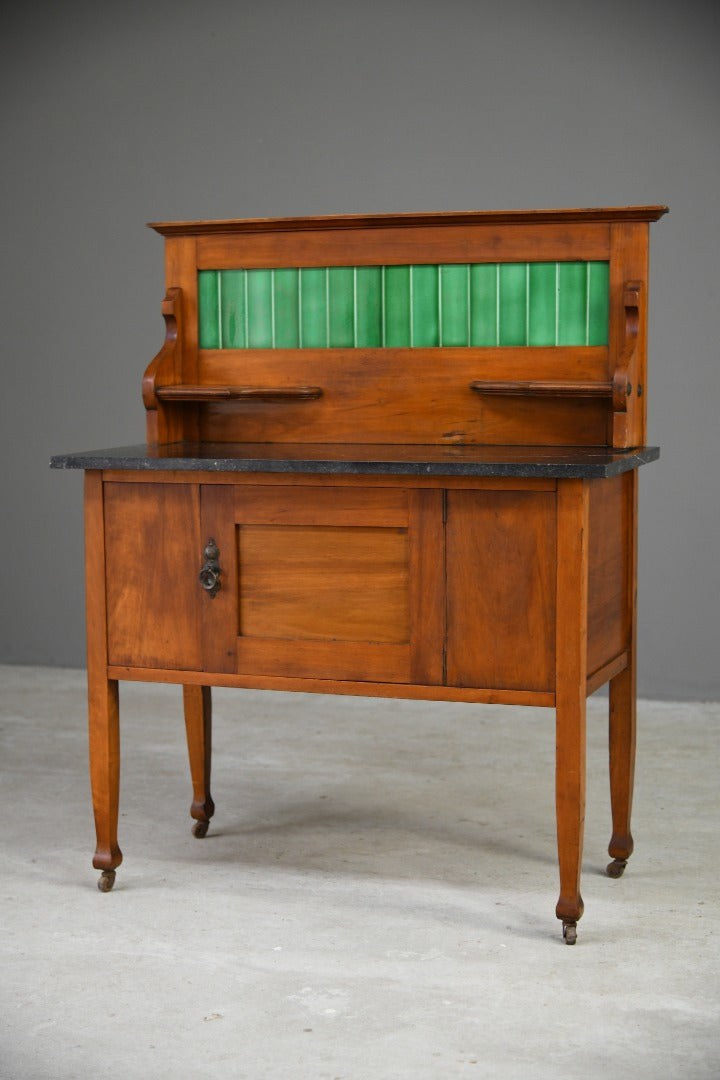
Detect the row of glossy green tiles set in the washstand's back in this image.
<box><xmin>198</xmin><ymin>262</ymin><xmax>609</xmax><ymax>349</ymax></box>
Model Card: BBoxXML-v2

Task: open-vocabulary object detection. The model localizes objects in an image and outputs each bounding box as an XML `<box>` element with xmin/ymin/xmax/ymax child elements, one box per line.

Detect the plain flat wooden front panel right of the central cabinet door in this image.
<box><xmin>447</xmin><ymin>490</ymin><xmax>556</xmax><ymax>690</ymax></box>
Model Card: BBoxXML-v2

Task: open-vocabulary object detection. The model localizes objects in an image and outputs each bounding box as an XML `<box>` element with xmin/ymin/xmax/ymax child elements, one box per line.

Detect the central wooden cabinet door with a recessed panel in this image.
<box><xmin>202</xmin><ymin>485</ymin><xmax>444</xmax><ymax>683</ymax></box>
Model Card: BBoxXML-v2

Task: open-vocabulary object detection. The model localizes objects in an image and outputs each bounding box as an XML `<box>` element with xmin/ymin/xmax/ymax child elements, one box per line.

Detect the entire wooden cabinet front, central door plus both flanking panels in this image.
<box><xmin>105</xmin><ymin>478</ymin><xmax>556</xmax><ymax>691</ymax></box>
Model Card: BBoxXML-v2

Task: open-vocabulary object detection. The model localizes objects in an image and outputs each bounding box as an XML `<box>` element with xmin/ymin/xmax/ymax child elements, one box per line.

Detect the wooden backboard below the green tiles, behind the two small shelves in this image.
<box><xmin>195</xmin><ymin>347</ymin><xmax>610</xmax><ymax>446</ymax></box>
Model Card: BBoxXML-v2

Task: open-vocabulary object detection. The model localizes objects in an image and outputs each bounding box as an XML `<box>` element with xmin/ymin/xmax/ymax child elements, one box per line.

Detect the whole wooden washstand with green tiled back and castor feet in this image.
<box><xmin>52</xmin><ymin>206</ymin><xmax>665</xmax><ymax>944</ymax></box>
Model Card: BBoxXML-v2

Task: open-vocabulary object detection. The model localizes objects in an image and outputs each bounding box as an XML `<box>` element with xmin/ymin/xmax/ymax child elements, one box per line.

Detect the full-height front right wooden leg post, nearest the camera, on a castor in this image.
<box><xmin>555</xmin><ymin>480</ymin><xmax>588</xmax><ymax>945</ymax></box>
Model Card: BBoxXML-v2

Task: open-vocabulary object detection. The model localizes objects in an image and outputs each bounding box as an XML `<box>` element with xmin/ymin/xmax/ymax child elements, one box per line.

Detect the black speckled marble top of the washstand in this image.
<box><xmin>50</xmin><ymin>443</ymin><xmax>660</xmax><ymax>478</ymax></box>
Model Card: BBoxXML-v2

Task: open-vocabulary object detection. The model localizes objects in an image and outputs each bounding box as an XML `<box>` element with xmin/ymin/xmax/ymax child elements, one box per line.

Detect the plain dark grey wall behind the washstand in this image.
<box><xmin>0</xmin><ymin>0</ymin><xmax>720</xmax><ymax>698</ymax></box>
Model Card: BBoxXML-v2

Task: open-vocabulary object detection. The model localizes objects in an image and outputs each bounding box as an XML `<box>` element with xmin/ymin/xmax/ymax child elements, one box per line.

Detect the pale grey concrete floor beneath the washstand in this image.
<box><xmin>0</xmin><ymin>667</ymin><xmax>720</xmax><ymax>1080</ymax></box>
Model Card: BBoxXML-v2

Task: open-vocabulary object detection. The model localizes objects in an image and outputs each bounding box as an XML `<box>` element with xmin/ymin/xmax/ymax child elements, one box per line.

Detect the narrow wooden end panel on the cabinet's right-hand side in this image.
<box><xmin>587</xmin><ymin>476</ymin><xmax>628</xmax><ymax>675</ymax></box>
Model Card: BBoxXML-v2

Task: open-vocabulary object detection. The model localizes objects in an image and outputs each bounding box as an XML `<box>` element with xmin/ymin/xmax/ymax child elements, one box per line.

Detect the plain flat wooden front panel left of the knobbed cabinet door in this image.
<box><xmin>105</xmin><ymin>483</ymin><xmax>202</xmax><ymax>670</ymax></box>
